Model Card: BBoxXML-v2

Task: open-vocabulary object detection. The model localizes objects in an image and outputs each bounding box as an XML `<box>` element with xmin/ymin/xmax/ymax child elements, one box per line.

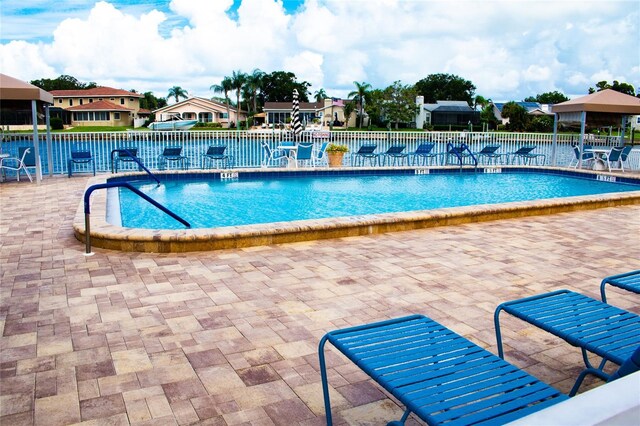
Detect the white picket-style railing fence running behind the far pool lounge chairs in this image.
<box><xmin>0</xmin><ymin>130</ymin><xmax>640</xmax><ymax>175</ymax></box>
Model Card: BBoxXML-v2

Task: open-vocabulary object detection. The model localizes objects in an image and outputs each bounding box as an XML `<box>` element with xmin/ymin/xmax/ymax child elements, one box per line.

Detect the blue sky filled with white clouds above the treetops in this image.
<box><xmin>0</xmin><ymin>0</ymin><xmax>640</xmax><ymax>101</ymax></box>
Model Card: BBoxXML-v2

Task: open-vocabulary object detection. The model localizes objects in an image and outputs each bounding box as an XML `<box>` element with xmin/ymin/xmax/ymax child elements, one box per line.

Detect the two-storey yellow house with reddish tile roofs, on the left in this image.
<box><xmin>51</xmin><ymin>86</ymin><xmax>143</xmax><ymax>127</ymax></box>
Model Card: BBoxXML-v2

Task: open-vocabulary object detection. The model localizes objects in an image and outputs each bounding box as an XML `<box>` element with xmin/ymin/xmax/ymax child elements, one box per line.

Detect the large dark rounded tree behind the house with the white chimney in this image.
<box><xmin>415</xmin><ymin>74</ymin><xmax>476</xmax><ymax>106</ymax></box>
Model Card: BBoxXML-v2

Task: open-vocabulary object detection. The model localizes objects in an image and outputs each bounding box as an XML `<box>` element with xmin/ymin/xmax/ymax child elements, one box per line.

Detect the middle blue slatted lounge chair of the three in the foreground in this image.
<box><xmin>494</xmin><ymin>290</ymin><xmax>640</xmax><ymax>396</ymax></box>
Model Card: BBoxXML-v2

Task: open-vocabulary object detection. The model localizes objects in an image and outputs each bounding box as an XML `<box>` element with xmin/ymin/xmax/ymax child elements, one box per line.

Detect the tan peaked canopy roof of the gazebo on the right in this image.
<box><xmin>551</xmin><ymin>89</ymin><xmax>640</xmax><ymax>115</ymax></box>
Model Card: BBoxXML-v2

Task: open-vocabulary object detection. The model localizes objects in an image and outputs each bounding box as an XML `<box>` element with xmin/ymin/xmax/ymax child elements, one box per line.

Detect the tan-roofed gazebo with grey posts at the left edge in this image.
<box><xmin>0</xmin><ymin>74</ymin><xmax>53</xmax><ymax>183</ymax></box>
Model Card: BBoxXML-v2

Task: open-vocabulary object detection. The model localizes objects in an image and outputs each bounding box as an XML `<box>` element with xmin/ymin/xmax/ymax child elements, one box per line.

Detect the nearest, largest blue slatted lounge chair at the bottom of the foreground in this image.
<box><xmin>318</xmin><ymin>315</ymin><xmax>568</xmax><ymax>425</ymax></box>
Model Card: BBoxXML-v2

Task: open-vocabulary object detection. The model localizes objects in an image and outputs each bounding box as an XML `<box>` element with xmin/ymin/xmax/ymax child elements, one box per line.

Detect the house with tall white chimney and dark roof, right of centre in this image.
<box><xmin>416</xmin><ymin>96</ymin><xmax>480</xmax><ymax>129</ymax></box>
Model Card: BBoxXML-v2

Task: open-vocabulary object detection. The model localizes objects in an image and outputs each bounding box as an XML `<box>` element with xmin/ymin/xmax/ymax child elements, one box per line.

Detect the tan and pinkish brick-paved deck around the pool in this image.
<box><xmin>0</xmin><ymin>176</ymin><xmax>640</xmax><ymax>426</ymax></box>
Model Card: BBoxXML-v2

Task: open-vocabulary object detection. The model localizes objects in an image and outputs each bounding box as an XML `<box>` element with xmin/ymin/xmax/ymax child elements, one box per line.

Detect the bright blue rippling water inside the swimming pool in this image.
<box><xmin>115</xmin><ymin>173</ymin><xmax>640</xmax><ymax>229</ymax></box>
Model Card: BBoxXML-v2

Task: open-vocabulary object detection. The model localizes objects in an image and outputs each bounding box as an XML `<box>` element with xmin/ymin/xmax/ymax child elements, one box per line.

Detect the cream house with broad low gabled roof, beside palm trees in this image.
<box><xmin>152</xmin><ymin>97</ymin><xmax>247</xmax><ymax>127</ymax></box>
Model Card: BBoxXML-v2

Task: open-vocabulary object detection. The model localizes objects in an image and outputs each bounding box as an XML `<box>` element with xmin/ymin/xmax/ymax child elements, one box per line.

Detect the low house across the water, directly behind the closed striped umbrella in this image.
<box><xmin>264</xmin><ymin>98</ymin><xmax>358</xmax><ymax>127</ymax></box>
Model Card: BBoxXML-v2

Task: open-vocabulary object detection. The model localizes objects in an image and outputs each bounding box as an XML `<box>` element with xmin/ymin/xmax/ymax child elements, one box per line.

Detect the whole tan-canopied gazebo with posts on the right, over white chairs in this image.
<box><xmin>551</xmin><ymin>89</ymin><xmax>640</xmax><ymax>167</ymax></box>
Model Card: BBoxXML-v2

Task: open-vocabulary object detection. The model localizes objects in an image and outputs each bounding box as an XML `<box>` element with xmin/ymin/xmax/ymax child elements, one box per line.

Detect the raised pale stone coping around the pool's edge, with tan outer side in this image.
<box><xmin>73</xmin><ymin>166</ymin><xmax>640</xmax><ymax>253</ymax></box>
